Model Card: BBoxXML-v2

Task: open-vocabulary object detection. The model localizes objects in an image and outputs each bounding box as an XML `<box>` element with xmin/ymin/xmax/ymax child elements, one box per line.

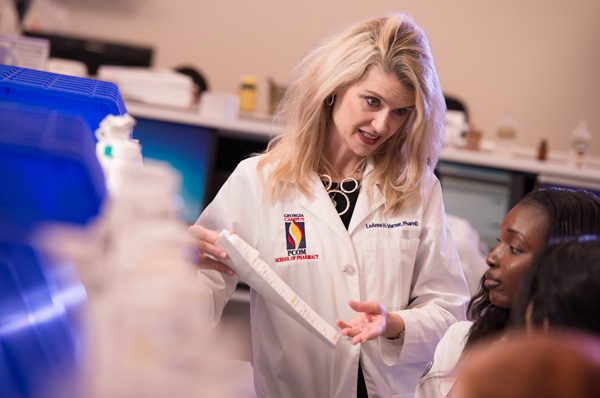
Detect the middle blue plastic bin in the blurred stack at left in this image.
<box><xmin>0</xmin><ymin>102</ymin><xmax>107</xmax><ymax>226</ymax></box>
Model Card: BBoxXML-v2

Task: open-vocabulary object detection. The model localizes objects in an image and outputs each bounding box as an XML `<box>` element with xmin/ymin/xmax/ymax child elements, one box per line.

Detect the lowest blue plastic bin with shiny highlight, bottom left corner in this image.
<box><xmin>0</xmin><ymin>223</ymin><xmax>87</xmax><ymax>398</ymax></box>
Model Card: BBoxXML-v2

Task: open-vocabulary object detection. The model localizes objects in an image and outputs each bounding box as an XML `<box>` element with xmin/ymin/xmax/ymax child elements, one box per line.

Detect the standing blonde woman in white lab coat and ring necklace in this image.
<box><xmin>190</xmin><ymin>14</ymin><xmax>469</xmax><ymax>398</ymax></box>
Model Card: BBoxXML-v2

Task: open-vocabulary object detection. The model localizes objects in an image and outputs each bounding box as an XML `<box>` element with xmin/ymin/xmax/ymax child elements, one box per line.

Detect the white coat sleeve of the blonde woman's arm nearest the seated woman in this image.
<box><xmin>390</xmin><ymin>176</ymin><xmax>469</xmax><ymax>363</ymax></box>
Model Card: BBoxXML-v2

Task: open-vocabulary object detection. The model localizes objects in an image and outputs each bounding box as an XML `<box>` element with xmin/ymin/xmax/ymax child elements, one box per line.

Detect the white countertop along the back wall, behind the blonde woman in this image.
<box><xmin>126</xmin><ymin>102</ymin><xmax>600</xmax><ymax>190</ymax></box>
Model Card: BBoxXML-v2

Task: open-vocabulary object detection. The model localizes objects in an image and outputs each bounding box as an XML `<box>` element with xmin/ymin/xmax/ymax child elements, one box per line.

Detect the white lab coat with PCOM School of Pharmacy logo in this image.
<box><xmin>197</xmin><ymin>157</ymin><xmax>469</xmax><ymax>398</ymax></box>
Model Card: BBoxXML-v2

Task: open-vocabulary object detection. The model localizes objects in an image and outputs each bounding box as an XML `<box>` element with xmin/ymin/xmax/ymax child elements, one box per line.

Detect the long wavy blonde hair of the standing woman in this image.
<box><xmin>258</xmin><ymin>13</ymin><xmax>446</xmax><ymax>213</ymax></box>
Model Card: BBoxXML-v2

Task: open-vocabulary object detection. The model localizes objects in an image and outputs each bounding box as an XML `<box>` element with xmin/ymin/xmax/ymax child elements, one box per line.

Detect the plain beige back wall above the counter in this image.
<box><xmin>55</xmin><ymin>0</ymin><xmax>600</xmax><ymax>156</ymax></box>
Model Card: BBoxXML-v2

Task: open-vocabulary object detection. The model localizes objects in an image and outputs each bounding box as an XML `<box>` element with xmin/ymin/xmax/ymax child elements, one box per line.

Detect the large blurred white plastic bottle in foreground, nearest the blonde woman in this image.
<box><xmin>84</xmin><ymin>160</ymin><xmax>220</xmax><ymax>398</ymax></box>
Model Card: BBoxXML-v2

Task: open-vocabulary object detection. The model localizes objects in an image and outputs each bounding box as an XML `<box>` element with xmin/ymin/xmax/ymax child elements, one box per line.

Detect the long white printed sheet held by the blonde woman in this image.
<box><xmin>217</xmin><ymin>230</ymin><xmax>340</xmax><ymax>348</ymax></box>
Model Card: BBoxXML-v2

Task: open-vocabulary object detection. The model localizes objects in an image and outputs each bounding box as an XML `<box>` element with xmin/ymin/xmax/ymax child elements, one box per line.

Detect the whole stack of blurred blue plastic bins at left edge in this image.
<box><xmin>0</xmin><ymin>65</ymin><xmax>127</xmax><ymax>398</ymax></box>
